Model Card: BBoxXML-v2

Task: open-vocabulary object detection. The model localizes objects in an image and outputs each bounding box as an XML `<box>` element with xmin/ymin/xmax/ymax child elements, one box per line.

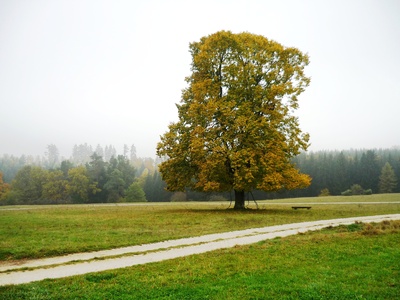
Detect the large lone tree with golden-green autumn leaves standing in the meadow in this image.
<box><xmin>157</xmin><ymin>31</ymin><xmax>310</xmax><ymax>209</ymax></box>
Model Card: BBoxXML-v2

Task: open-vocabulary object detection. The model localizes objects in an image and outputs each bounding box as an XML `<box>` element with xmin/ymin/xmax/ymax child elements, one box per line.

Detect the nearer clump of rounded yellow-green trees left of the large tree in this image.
<box><xmin>3</xmin><ymin>153</ymin><xmax>146</xmax><ymax>204</ymax></box>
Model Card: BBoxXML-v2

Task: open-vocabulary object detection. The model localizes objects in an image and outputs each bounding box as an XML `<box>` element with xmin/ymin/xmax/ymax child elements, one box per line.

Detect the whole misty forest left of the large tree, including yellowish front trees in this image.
<box><xmin>0</xmin><ymin>144</ymin><xmax>160</xmax><ymax>204</ymax></box>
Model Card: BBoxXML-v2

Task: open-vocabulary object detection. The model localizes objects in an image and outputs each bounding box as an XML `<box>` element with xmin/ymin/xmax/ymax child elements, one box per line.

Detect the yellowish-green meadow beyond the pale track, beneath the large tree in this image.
<box><xmin>0</xmin><ymin>194</ymin><xmax>400</xmax><ymax>261</ymax></box>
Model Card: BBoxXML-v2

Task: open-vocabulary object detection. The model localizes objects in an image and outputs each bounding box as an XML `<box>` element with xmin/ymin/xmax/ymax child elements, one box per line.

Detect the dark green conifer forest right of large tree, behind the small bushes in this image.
<box><xmin>293</xmin><ymin>148</ymin><xmax>400</xmax><ymax>197</ymax></box>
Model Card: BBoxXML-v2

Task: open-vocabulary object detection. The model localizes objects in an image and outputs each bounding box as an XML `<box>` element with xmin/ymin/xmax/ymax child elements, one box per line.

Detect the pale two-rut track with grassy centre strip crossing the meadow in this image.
<box><xmin>0</xmin><ymin>214</ymin><xmax>400</xmax><ymax>286</ymax></box>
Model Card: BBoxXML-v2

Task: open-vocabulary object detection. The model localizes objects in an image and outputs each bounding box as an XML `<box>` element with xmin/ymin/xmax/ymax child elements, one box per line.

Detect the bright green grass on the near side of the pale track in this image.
<box><xmin>0</xmin><ymin>221</ymin><xmax>400</xmax><ymax>299</ymax></box>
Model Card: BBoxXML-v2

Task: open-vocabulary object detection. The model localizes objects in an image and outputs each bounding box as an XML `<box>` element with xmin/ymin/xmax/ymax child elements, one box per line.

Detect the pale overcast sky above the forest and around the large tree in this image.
<box><xmin>0</xmin><ymin>0</ymin><xmax>400</xmax><ymax>158</ymax></box>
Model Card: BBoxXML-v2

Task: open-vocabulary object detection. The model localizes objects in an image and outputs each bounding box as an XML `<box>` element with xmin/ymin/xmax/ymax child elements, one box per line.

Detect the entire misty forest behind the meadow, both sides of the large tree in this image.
<box><xmin>0</xmin><ymin>144</ymin><xmax>400</xmax><ymax>205</ymax></box>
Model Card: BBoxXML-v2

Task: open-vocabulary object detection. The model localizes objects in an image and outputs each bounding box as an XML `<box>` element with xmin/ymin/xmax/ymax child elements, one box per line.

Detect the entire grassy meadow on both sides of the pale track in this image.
<box><xmin>0</xmin><ymin>194</ymin><xmax>400</xmax><ymax>299</ymax></box>
